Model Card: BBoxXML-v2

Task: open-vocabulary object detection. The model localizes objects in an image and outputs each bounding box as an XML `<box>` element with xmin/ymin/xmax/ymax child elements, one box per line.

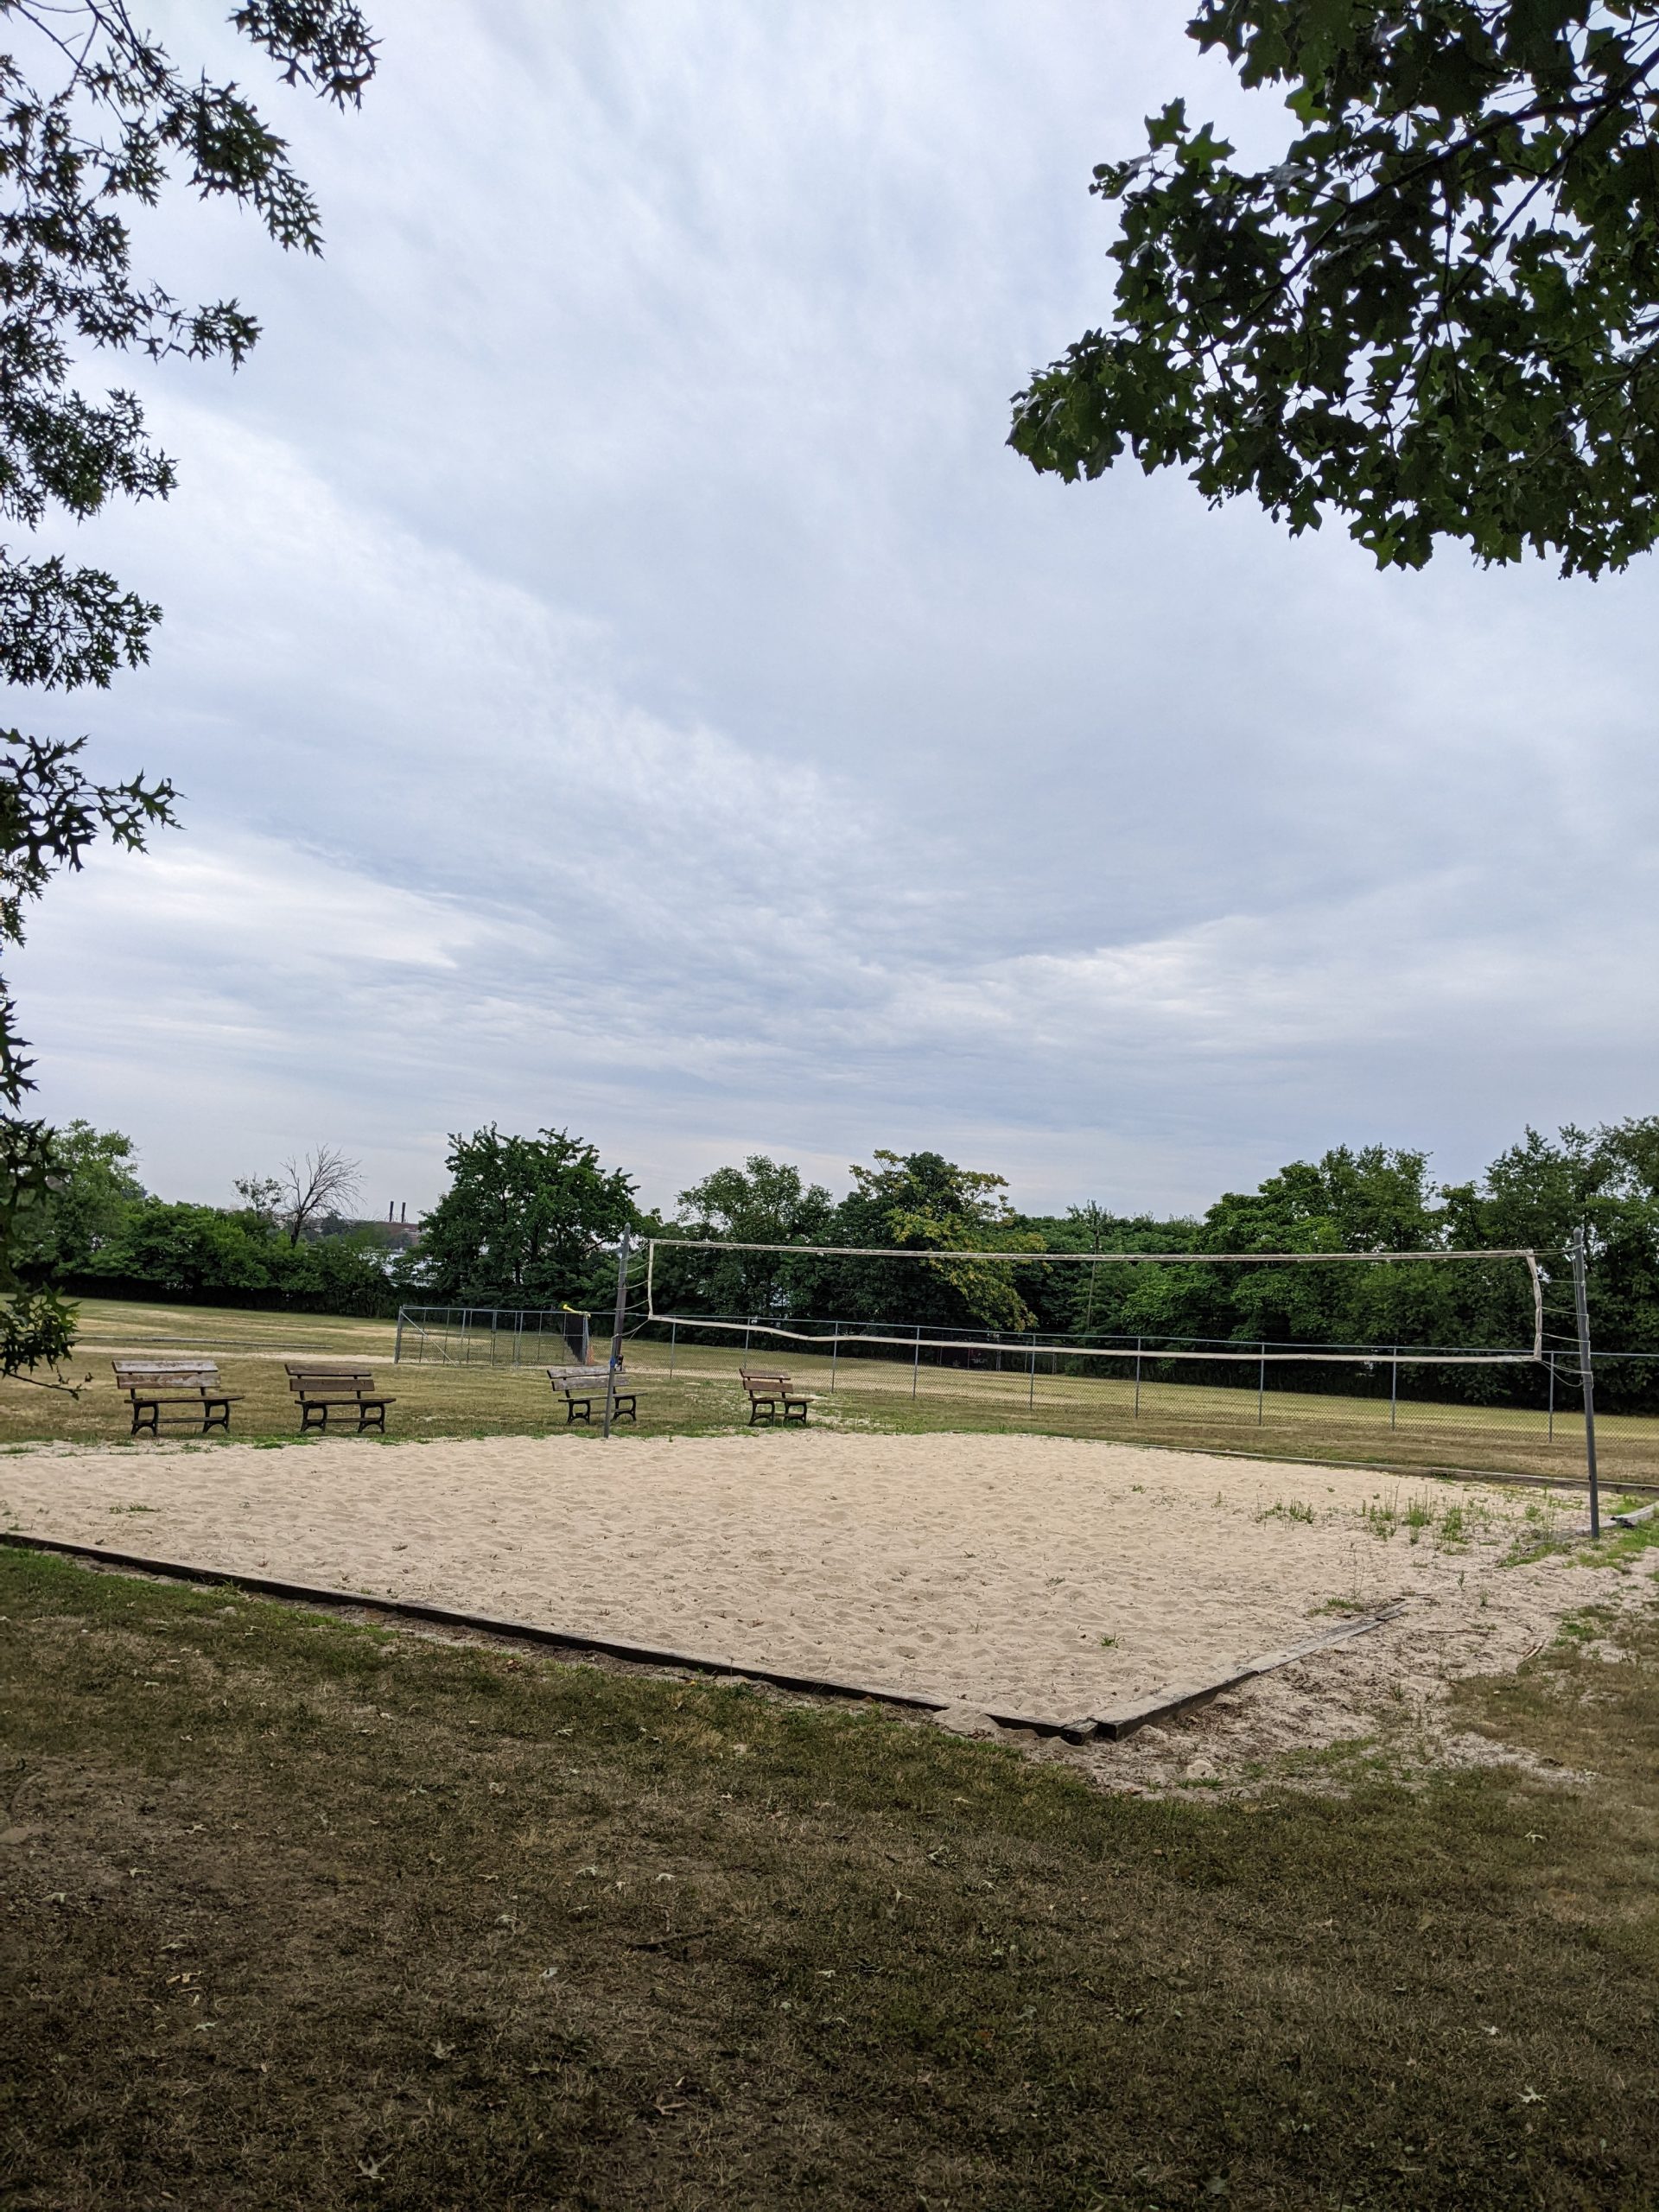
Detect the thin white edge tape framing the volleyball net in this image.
<box><xmin>646</xmin><ymin>1236</ymin><xmax>1544</xmax><ymax>1367</ymax></box>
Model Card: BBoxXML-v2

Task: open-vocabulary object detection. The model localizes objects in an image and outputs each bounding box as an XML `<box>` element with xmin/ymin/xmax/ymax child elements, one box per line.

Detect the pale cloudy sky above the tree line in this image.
<box><xmin>7</xmin><ymin>0</ymin><xmax>1659</xmax><ymax>1214</ymax></box>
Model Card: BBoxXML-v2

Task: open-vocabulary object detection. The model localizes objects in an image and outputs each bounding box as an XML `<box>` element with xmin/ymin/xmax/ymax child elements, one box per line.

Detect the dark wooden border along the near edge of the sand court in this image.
<box><xmin>0</xmin><ymin>1529</ymin><xmax>1405</xmax><ymax>1743</ymax></box>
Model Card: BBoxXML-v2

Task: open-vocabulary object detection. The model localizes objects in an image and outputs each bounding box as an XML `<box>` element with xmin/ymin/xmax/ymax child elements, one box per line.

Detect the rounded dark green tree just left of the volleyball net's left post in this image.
<box><xmin>420</xmin><ymin>1123</ymin><xmax>637</xmax><ymax>1305</ymax></box>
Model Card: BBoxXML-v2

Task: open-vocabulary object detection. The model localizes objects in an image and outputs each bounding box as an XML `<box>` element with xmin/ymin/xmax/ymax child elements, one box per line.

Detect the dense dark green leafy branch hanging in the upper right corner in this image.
<box><xmin>1011</xmin><ymin>0</ymin><xmax>1659</xmax><ymax>575</ymax></box>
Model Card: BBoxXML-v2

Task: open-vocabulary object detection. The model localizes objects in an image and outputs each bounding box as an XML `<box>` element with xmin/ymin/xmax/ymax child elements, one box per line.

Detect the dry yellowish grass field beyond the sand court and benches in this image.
<box><xmin>13</xmin><ymin>1300</ymin><xmax>1659</xmax><ymax>1484</ymax></box>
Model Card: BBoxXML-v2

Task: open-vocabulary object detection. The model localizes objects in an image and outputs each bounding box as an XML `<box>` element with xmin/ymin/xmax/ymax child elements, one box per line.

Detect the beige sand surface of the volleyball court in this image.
<box><xmin>0</xmin><ymin>1431</ymin><xmax>1646</xmax><ymax>1719</ymax></box>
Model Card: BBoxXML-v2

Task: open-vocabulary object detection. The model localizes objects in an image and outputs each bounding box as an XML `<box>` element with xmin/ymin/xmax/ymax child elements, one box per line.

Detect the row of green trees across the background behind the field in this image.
<box><xmin>29</xmin><ymin>1115</ymin><xmax>1659</xmax><ymax>1380</ymax></box>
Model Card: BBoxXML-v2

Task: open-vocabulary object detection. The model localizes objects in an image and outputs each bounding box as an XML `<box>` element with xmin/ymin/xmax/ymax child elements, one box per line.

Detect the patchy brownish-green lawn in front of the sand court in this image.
<box><xmin>0</xmin><ymin>1540</ymin><xmax>1659</xmax><ymax>2212</ymax></box>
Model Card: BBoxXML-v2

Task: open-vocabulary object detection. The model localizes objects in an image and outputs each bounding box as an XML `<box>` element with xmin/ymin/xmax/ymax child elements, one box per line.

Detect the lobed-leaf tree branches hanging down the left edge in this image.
<box><xmin>0</xmin><ymin>0</ymin><xmax>374</xmax><ymax>1374</ymax></box>
